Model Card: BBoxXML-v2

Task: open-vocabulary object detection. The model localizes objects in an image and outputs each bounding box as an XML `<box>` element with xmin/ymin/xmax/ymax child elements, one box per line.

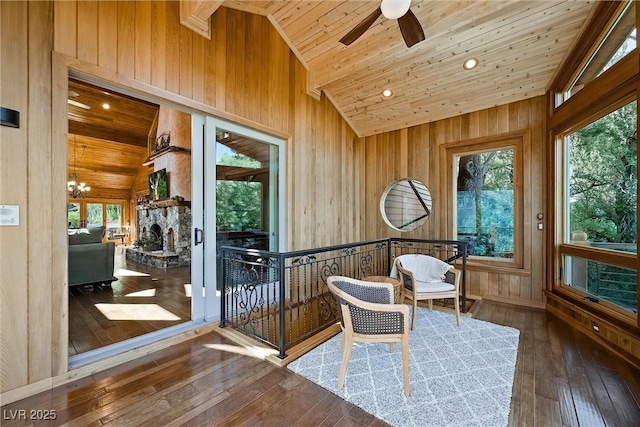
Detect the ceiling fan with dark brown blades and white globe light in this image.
<box><xmin>340</xmin><ymin>0</ymin><xmax>424</xmax><ymax>47</ymax></box>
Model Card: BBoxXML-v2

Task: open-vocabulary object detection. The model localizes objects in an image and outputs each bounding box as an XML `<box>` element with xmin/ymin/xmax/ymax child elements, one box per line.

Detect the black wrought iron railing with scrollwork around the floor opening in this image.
<box><xmin>218</xmin><ymin>238</ymin><xmax>467</xmax><ymax>358</ymax></box>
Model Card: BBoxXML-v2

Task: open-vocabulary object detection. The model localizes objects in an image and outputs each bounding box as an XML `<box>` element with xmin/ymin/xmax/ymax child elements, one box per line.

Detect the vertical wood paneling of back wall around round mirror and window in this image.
<box><xmin>363</xmin><ymin>97</ymin><xmax>545</xmax><ymax>302</ymax></box>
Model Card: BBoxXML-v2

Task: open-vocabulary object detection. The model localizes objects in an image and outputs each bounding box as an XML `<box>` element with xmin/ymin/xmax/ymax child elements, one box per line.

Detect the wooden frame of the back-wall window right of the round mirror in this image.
<box><xmin>443</xmin><ymin>131</ymin><xmax>530</xmax><ymax>270</ymax></box>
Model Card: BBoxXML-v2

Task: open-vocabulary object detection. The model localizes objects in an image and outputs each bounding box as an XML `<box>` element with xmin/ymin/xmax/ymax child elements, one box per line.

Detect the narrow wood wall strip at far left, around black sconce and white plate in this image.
<box><xmin>0</xmin><ymin>2</ymin><xmax>30</xmax><ymax>392</ymax></box>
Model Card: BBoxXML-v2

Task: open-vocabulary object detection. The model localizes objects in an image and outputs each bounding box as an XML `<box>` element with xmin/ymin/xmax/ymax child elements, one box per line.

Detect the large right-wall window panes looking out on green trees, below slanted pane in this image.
<box><xmin>562</xmin><ymin>101</ymin><xmax>638</xmax><ymax>313</ymax></box>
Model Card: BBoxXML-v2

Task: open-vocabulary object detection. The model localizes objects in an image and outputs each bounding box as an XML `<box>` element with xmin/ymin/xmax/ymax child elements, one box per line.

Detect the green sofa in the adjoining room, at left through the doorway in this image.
<box><xmin>68</xmin><ymin>227</ymin><xmax>117</xmax><ymax>286</ymax></box>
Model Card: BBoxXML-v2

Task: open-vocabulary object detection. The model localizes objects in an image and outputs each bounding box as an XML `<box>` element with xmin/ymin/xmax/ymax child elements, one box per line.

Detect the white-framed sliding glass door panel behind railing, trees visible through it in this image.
<box><xmin>204</xmin><ymin>117</ymin><xmax>285</xmax><ymax>319</ymax></box>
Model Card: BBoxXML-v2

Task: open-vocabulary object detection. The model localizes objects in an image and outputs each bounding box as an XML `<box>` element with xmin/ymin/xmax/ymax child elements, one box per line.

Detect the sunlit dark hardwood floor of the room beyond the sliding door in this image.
<box><xmin>69</xmin><ymin>246</ymin><xmax>191</xmax><ymax>356</ymax></box>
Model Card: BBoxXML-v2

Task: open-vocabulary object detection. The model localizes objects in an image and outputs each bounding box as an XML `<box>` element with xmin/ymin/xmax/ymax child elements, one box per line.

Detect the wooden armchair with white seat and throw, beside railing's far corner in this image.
<box><xmin>394</xmin><ymin>254</ymin><xmax>462</xmax><ymax>330</ymax></box>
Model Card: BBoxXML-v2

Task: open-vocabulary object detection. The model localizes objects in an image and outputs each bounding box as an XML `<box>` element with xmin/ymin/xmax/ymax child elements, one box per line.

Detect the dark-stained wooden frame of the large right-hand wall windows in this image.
<box><xmin>547</xmin><ymin>2</ymin><xmax>640</xmax><ymax>327</ymax></box>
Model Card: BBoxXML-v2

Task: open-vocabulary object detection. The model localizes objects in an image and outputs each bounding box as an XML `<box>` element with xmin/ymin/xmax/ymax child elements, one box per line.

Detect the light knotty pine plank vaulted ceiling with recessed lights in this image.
<box><xmin>181</xmin><ymin>0</ymin><xmax>596</xmax><ymax>136</ymax></box>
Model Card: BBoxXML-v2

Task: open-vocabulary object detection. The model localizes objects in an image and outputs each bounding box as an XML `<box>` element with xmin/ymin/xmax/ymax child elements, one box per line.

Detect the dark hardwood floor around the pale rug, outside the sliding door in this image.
<box><xmin>2</xmin><ymin>301</ymin><xmax>640</xmax><ymax>427</ymax></box>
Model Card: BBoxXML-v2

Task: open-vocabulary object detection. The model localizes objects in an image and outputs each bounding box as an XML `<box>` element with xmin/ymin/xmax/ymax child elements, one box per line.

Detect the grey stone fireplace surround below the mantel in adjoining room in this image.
<box><xmin>138</xmin><ymin>206</ymin><xmax>191</xmax><ymax>266</ymax></box>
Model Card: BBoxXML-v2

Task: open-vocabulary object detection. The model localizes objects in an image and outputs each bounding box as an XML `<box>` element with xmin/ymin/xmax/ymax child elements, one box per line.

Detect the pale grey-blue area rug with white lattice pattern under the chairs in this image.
<box><xmin>288</xmin><ymin>307</ymin><xmax>520</xmax><ymax>427</ymax></box>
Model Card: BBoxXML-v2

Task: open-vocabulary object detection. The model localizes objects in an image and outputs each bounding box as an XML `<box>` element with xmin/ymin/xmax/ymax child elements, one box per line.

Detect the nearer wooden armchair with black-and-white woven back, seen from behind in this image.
<box><xmin>327</xmin><ymin>276</ymin><xmax>409</xmax><ymax>396</ymax></box>
